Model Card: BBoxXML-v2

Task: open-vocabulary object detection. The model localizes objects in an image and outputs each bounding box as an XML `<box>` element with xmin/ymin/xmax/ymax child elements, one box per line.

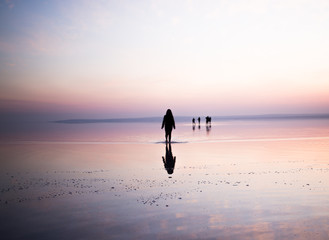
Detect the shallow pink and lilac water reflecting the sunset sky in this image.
<box><xmin>0</xmin><ymin>119</ymin><xmax>329</xmax><ymax>239</ymax></box>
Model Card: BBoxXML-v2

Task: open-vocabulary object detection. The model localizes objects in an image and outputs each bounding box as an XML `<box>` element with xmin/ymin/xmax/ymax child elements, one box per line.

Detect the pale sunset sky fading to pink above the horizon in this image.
<box><xmin>0</xmin><ymin>0</ymin><xmax>329</xmax><ymax>120</ymax></box>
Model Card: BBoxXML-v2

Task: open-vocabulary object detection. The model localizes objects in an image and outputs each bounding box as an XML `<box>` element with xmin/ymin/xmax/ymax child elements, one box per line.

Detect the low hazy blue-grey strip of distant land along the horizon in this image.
<box><xmin>51</xmin><ymin>114</ymin><xmax>329</xmax><ymax>124</ymax></box>
